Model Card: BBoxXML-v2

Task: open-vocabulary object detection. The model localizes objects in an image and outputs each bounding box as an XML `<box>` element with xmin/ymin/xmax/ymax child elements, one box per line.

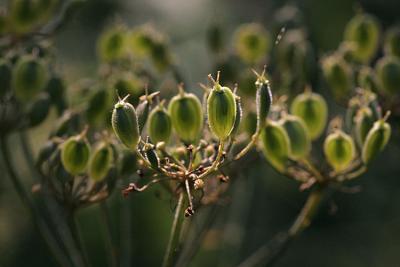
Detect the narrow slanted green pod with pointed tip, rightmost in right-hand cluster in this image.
<box><xmin>362</xmin><ymin>118</ymin><xmax>391</xmax><ymax>164</ymax></box>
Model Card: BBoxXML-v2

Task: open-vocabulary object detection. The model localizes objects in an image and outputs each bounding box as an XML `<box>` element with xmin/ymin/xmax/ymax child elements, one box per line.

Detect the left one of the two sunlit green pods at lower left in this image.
<box><xmin>61</xmin><ymin>135</ymin><xmax>90</xmax><ymax>175</ymax></box>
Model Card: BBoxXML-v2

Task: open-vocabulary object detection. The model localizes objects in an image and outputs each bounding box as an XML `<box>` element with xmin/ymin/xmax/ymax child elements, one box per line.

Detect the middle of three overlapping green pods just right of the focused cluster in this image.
<box><xmin>279</xmin><ymin>115</ymin><xmax>311</xmax><ymax>159</ymax></box>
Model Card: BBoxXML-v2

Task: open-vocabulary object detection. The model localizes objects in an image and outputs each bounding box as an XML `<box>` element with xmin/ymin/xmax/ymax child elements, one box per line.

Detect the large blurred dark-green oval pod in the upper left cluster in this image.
<box><xmin>11</xmin><ymin>55</ymin><xmax>48</xmax><ymax>102</ymax></box>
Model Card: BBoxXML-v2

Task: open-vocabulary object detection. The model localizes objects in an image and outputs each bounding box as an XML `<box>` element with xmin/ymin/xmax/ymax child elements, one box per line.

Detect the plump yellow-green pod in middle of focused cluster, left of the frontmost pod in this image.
<box><xmin>168</xmin><ymin>90</ymin><xmax>203</xmax><ymax>144</ymax></box>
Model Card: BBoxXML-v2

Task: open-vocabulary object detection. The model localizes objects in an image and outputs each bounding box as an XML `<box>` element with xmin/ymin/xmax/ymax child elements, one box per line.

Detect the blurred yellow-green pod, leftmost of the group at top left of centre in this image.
<box><xmin>97</xmin><ymin>25</ymin><xmax>127</xmax><ymax>61</ymax></box>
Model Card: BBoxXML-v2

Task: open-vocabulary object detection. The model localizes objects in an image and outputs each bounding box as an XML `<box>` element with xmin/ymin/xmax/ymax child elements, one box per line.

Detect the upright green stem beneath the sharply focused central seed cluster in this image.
<box><xmin>162</xmin><ymin>191</ymin><xmax>184</xmax><ymax>267</ymax></box>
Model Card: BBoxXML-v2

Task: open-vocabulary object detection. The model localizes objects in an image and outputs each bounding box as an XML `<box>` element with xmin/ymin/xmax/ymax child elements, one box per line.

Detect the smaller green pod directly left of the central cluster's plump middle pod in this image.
<box><xmin>147</xmin><ymin>104</ymin><xmax>172</xmax><ymax>144</ymax></box>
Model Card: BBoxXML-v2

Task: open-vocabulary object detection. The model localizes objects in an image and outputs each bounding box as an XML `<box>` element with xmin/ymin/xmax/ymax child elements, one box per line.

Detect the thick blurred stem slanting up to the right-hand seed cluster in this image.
<box><xmin>238</xmin><ymin>185</ymin><xmax>328</xmax><ymax>267</ymax></box>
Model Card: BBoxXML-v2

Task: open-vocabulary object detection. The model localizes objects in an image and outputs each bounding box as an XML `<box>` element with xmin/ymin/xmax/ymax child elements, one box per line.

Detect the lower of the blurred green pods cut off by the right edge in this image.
<box><xmin>376</xmin><ymin>56</ymin><xmax>400</xmax><ymax>94</ymax></box>
